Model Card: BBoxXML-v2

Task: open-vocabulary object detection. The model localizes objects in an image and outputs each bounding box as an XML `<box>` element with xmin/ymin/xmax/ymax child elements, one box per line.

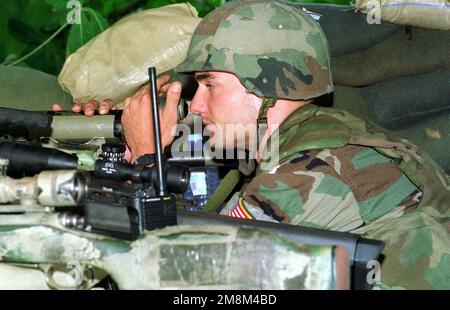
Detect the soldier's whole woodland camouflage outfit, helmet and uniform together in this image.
<box><xmin>177</xmin><ymin>0</ymin><xmax>450</xmax><ymax>289</ymax></box>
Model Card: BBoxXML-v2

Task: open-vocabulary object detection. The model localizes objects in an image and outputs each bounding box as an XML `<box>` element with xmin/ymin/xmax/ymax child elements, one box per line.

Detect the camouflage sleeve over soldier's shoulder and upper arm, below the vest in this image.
<box><xmin>244</xmin><ymin>144</ymin><xmax>417</xmax><ymax>230</ymax></box>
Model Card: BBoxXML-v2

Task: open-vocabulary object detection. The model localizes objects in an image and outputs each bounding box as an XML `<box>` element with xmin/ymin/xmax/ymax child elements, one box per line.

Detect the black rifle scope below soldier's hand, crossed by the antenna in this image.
<box><xmin>94</xmin><ymin>160</ymin><xmax>190</xmax><ymax>193</ymax></box>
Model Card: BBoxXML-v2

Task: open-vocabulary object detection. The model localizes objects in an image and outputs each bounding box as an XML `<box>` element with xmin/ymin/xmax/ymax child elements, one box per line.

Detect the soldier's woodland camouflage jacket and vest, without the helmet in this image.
<box><xmin>223</xmin><ymin>104</ymin><xmax>450</xmax><ymax>289</ymax></box>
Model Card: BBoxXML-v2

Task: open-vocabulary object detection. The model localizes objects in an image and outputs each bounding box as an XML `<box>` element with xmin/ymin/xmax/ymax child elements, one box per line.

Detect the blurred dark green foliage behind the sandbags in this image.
<box><xmin>0</xmin><ymin>0</ymin><xmax>351</xmax><ymax>75</ymax></box>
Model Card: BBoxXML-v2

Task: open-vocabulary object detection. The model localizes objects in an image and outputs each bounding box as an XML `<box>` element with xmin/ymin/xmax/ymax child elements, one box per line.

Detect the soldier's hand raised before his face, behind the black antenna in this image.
<box><xmin>122</xmin><ymin>75</ymin><xmax>181</xmax><ymax>162</ymax></box>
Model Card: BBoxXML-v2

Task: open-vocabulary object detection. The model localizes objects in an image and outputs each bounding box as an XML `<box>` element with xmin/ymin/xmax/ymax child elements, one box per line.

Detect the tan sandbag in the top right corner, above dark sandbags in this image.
<box><xmin>355</xmin><ymin>0</ymin><xmax>450</xmax><ymax>30</ymax></box>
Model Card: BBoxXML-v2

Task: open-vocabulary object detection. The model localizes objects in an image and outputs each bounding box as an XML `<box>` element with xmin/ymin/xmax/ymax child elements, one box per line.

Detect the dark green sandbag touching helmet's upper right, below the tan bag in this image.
<box><xmin>301</xmin><ymin>3</ymin><xmax>402</xmax><ymax>56</ymax></box>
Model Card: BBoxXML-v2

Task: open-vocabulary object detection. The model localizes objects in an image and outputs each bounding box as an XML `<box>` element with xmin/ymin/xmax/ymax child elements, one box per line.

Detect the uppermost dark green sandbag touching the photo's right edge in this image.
<box><xmin>331</xmin><ymin>27</ymin><xmax>450</xmax><ymax>86</ymax></box>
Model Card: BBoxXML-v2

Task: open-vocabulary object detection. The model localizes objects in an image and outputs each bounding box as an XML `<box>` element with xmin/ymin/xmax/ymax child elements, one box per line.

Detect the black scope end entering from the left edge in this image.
<box><xmin>0</xmin><ymin>142</ymin><xmax>78</xmax><ymax>178</ymax></box>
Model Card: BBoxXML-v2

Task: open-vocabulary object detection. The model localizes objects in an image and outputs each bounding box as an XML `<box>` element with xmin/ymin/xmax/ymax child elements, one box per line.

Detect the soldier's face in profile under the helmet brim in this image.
<box><xmin>191</xmin><ymin>71</ymin><xmax>261</xmax><ymax>148</ymax></box>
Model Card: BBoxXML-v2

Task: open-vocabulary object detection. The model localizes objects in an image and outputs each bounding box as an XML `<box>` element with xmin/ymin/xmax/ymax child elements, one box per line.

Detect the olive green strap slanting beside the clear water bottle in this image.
<box><xmin>203</xmin><ymin>169</ymin><xmax>241</xmax><ymax>213</ymax></box>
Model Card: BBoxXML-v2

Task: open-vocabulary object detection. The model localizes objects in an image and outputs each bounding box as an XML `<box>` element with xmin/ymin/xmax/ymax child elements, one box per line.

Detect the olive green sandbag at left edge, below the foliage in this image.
<box><xmin>0</xmin><ymin>66</ymin><xmax>72</xmax><ymax>111</ymax></box>
